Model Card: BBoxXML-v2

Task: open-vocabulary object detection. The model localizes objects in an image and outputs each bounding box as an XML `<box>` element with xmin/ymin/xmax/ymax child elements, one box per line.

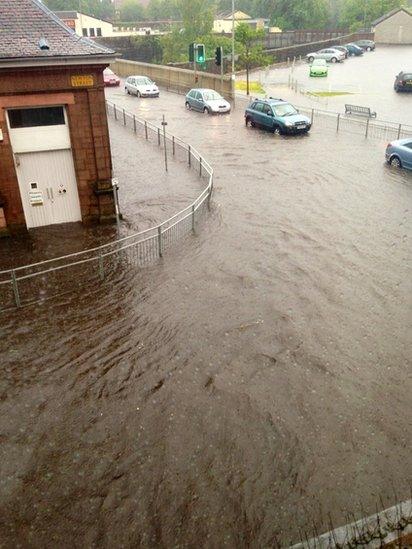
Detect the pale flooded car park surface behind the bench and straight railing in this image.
<box><xmin>249</xmin><ymin>44</ymin><xmax>412</xmax><ymax>125</ymax></box>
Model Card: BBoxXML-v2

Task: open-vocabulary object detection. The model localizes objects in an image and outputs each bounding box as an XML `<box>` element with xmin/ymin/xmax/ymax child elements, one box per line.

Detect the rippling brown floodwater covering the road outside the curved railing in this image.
<box><xmin>0</xmin><ymin>74</ymin><xmax>412</xmax><ymax>548</ymax></box>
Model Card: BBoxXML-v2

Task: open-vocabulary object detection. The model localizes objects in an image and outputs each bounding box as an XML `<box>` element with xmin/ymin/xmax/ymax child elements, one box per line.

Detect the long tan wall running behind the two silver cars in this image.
<box><xmin>111</xmin><ymin>59</ymin><xmax>234</xmax><ymax>99</ymax></box>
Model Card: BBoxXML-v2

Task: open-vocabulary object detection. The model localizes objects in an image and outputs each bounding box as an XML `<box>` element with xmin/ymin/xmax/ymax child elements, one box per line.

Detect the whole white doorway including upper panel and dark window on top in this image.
<box><xmin>7</xmin><ymin>105</ymin><xmax>82</xmax><ymax>228</ymax></box>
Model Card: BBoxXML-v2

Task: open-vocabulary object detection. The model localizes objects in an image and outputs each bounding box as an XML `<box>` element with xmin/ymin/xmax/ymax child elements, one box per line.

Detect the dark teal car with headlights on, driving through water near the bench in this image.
<box><xmin>245</xmin><ymin>97</ymin><xmax>311</xmax><ymax>134</ymax></box>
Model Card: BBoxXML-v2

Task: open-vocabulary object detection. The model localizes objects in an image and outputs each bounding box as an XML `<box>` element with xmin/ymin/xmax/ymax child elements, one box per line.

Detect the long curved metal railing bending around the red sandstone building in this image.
<box><xmin>0</xmin><ymin>101</ymin><xmax>213</xmax><ymax>311</ymax></box>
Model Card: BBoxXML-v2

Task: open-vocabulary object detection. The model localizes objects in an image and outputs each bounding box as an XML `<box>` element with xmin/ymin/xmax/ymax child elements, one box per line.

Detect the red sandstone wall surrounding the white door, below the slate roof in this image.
<box><xmin>0</xmin><ymin>66</ymin><xmax>114</xmax><ymax>229</ymax></box>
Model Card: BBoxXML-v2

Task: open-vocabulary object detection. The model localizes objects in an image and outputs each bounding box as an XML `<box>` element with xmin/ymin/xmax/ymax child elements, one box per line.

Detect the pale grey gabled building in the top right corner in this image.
<box><xmin>372</xmin><ymin>8</ymin><xmax>412</xmax><ymax>44</ymax></box>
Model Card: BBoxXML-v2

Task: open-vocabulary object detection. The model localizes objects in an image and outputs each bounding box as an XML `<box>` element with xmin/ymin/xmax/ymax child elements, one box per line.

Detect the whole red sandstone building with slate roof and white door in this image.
<box><xmin>0</xmin><ymin>0</ymin><xmax>115</xmax><ymax>234</ymax></box>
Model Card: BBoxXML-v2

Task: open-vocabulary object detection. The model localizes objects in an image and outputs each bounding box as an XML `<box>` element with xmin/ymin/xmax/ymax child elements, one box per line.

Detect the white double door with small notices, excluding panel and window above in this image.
<box><xmin>15</xmin><ymin>149</ymin><xmax>82</xmax><ymax>228</ymax></box>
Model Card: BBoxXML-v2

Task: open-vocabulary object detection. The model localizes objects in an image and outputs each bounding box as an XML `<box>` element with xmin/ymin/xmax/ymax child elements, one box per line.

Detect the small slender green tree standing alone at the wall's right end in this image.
<box><xmin>235</xmin><ymin>23</ymin><xmax>271</xmax><ymax>95</ymax></box>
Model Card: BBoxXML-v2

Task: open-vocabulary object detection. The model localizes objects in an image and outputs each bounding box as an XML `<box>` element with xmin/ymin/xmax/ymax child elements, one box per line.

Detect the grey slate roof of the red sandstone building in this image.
<box><xmin>0</xmin><ymin>0</ymin><xmax>114</xmax><ymax>64</ymax></box>
